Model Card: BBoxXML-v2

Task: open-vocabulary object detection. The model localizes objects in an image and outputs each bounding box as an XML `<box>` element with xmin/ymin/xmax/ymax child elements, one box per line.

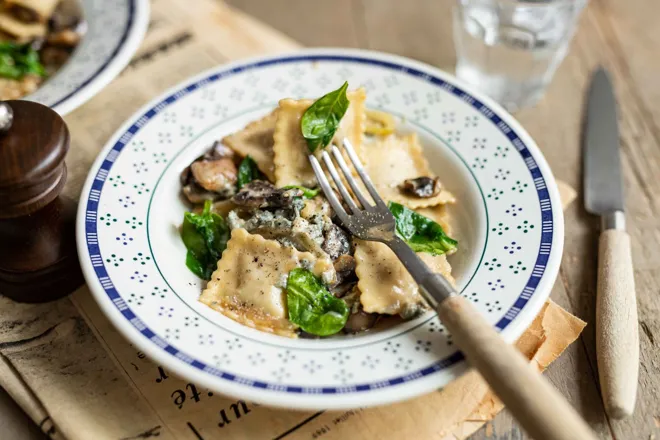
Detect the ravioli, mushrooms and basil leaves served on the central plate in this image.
<box><xmin>181</xmin><ymin>83</ymin><xmax>458</xmax><ymax>337</ymax></box>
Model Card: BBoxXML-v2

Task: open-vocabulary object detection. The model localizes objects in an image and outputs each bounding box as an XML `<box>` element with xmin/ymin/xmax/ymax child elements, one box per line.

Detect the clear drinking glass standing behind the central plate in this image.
<box><xmin>454</xmin><ymin>0</ymin><xmax>587</xmax><ymax>112</ymax></box>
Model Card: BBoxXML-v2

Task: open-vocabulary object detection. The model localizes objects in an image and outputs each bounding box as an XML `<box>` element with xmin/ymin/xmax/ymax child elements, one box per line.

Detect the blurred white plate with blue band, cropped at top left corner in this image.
<box><xmin>23</xmin><ymin>0</ymin><xmax>149</xmax><ymax>115</ymax></box>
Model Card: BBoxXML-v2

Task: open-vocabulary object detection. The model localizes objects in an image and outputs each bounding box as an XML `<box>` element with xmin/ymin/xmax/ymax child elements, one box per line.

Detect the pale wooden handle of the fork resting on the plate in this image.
<box><xmin>438</xmin><ymin>296</ymin><xmax>596</xmax><ymax>440</ymax></box>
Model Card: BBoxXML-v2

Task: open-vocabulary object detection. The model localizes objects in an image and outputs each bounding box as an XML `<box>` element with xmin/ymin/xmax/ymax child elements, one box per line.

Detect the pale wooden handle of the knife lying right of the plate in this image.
<box><xmin>596</xmin><ymin>229</ymin><xmax>639</xmax><ymax>419</ymax></box>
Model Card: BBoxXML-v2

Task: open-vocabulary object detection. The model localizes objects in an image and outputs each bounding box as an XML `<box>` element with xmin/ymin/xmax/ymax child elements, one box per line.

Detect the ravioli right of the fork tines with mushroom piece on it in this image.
<box><xmin>362</xmin><ymin>133</ymin><xmax>456</xmax><ymax>209</ymax></box>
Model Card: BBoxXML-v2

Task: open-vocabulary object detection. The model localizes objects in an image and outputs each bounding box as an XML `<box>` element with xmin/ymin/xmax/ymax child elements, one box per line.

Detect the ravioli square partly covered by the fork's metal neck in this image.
<box><xmin>355</xmin><ymin>240</ymin><xmax>454</xmax><ymax>315</ymax></box>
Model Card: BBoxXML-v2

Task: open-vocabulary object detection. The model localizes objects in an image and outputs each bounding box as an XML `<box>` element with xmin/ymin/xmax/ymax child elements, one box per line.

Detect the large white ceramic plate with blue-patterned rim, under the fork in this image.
<box><xmin>78</xmin><ymin>49</ymin><xmax>563</xmax><ymax>409</ymax></box>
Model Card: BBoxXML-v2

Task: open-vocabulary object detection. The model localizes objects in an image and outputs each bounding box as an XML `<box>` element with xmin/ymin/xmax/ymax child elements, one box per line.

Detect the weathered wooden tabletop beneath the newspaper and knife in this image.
<box><xmin>0</xmin><ymin>0</ymin><xmax>660</xmax><ymax>440</ymax></box>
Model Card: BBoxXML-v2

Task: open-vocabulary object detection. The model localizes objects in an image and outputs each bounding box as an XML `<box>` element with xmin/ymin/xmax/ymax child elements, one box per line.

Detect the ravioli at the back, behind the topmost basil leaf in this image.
<box><xmin>273</xmin><ymin>89</ymin><xmax>366</xmax><ymax>188</ymax></box>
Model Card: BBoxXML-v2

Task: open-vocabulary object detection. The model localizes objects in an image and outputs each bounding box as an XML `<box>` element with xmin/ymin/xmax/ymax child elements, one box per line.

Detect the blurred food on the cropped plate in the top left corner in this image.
<box><xmin>0</xmin><ymin>0</ymin><xmax>84</xmax><ymax>100</ymax></box>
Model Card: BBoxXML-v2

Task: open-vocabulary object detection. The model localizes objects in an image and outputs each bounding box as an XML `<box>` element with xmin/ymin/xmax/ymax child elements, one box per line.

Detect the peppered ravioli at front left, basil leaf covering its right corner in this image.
<box><xmin>199</xmin><ymin>228</ymin><xmax>336</xmax><ymax>338</ymax></box>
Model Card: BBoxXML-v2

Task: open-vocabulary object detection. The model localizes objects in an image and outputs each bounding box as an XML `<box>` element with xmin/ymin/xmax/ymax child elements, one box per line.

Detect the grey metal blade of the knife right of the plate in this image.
<box><xmin>584</xmin><ymin>68</ymin><xmax>624</xmax><ymax>215</ymax></box>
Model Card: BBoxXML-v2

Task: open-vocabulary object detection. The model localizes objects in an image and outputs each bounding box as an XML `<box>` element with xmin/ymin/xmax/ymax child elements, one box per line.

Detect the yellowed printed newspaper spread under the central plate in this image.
<box><xmin>0</xmin><ymin>0</ymin><xmax>584</xmax><ymax>440</ymax></box>
